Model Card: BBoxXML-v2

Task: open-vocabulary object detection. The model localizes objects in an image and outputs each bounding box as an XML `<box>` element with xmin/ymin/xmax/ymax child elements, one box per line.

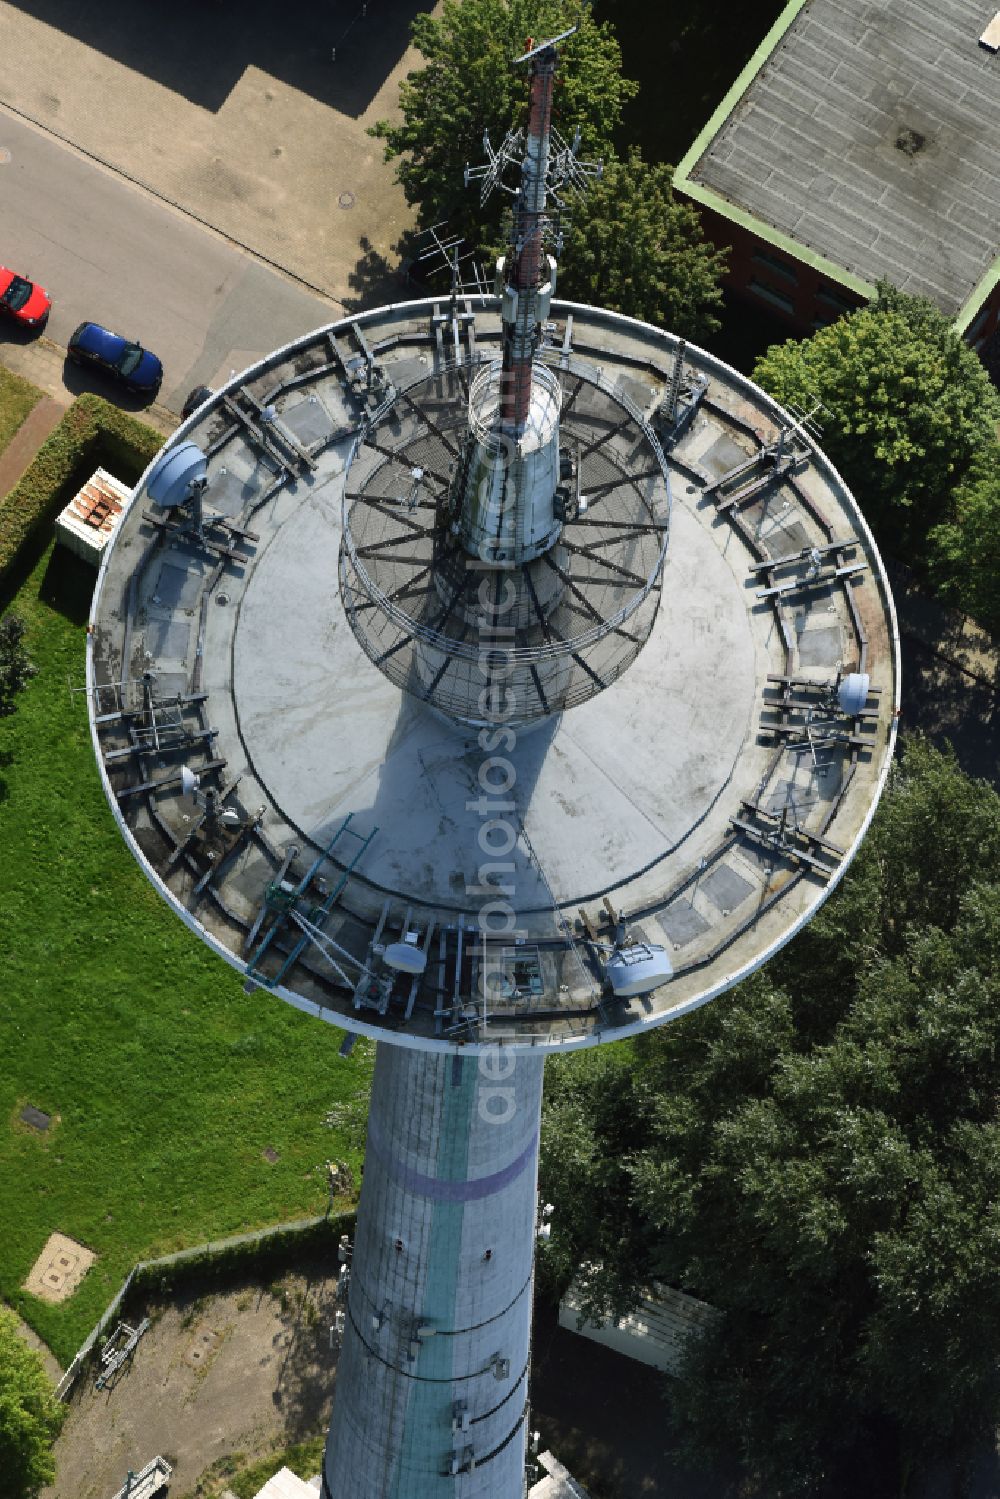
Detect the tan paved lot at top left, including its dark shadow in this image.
<box><xmin>0</xmin><ymin>0</ymin><xmax>434</xmax><ymax>301</ymax></box>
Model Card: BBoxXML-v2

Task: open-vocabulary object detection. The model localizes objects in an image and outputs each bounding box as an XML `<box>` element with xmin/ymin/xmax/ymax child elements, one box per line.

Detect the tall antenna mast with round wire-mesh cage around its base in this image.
<box><xmin>340</xmin><ymin>23</ymin><xmax>670</xmax><ymax>727</ymax></box>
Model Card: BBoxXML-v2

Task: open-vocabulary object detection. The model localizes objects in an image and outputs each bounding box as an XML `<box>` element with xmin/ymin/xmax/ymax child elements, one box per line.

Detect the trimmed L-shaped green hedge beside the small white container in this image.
<box><xmin>0</xmin><ymin>394</ymin><xmax>163</xmax><ymax>583</ymax></box>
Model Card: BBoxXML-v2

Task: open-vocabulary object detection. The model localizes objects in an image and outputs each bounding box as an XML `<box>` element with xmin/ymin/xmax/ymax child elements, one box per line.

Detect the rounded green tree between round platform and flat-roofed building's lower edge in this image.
<box><xmin>754</xmin><ymin>283</ymin><xmax>1000</xmax><ymax>556</ymax></box>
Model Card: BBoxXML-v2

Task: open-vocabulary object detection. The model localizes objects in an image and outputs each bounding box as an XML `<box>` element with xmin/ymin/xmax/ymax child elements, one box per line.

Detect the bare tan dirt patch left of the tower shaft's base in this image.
<box><xmin>43</xmin><ymin>1267</ymin><xmax>344</xmax><ymax>1499</ymax></box>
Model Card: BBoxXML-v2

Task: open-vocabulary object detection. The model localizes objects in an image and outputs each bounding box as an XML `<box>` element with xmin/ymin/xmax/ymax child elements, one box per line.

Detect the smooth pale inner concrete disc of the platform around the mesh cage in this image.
<box><xmin>232</xmin><ymin>502</ymin><xmax>758</xmax><ymax>911</ymax></box>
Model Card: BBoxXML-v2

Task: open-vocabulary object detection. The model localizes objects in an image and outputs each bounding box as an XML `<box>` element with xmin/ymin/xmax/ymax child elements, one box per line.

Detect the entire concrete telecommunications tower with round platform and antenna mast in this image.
<box><xmin>88</xmin><ymin>33</ymin><xmax>898</xmax><ymax>1499</ymax></box>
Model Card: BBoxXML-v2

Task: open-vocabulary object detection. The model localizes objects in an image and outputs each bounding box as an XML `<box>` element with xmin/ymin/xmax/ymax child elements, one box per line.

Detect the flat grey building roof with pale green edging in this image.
<box><xmin>675</xmin><ymin>0</ymin><xmax>1000</xmax><ymax>330</ymax></box>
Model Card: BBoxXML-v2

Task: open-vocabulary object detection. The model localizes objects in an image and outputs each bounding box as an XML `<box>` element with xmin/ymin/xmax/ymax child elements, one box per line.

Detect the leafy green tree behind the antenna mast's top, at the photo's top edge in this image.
<box><xmin>372</xmin><ymin>0</ymin><xmax>637</xmax><ymax>249</ymax></box>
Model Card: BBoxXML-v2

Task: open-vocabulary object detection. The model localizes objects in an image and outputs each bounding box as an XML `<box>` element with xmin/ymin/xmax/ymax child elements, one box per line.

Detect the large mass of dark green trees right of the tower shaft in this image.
<box><xmin>541</xmin><ymin>739</ymin><xmax>1000</xmax><ymax>1499</ymax></box>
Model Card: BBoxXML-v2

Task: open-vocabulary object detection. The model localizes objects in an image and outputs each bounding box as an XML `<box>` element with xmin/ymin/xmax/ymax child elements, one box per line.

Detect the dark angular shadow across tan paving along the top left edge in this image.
<box><xmin>5</xmin><ymin>0</ymin><xmax>430</xmax><ymax>116</ymax></box>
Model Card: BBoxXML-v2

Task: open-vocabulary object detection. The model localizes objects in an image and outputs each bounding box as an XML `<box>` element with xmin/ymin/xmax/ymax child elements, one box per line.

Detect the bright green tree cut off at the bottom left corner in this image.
<box><xmin>0</xmin><ymin>1310</ymin><xmax>66</xmax><ymax>1499</ymax></box>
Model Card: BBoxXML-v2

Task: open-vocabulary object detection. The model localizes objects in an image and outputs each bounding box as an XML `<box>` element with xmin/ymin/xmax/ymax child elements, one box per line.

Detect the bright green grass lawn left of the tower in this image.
<box><xmin>0</xmin><ymin>546</ymin><xmax>373</xmax><ymax>1363</ymax></box>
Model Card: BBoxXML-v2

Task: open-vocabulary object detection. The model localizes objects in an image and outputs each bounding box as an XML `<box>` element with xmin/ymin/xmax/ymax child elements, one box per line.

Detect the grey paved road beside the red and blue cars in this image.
<box><xmin>0</xmin><ymin>106</ymin><xmax>342</xmax><ymax>412</ymax></box>
